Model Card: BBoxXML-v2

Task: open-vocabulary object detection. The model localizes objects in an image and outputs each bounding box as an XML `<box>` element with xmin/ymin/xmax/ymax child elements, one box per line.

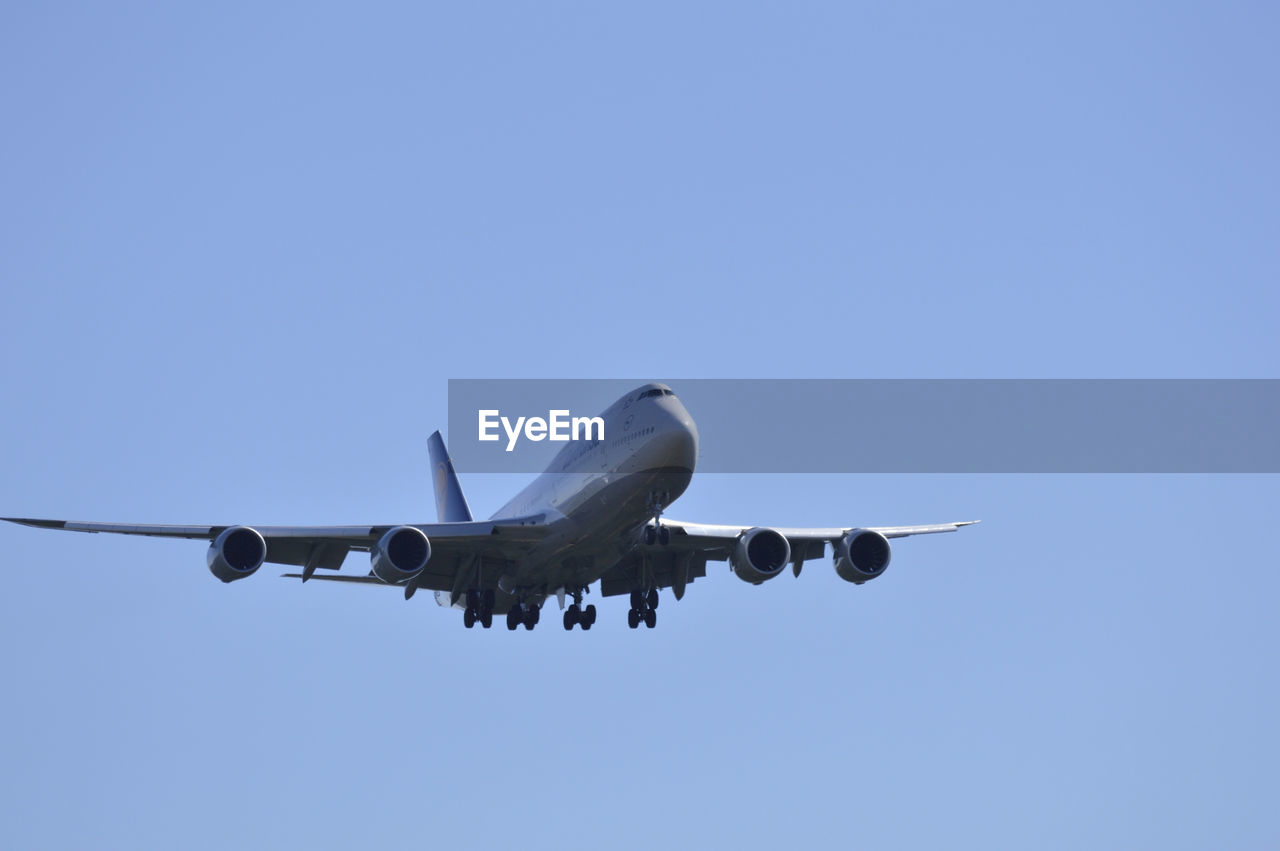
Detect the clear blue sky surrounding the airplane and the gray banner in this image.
<box><xmin>0</xmin><ymin>3</ymin><xmax>1280</xmax><ymax>848</ymax></box>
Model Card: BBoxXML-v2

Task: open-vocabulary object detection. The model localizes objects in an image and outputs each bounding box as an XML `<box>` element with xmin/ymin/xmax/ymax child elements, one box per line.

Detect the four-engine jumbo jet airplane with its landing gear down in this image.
<box><xmin>0</xmin><ymin>383</ymin><xmax>978</xmax><ymax>631</ymax></box>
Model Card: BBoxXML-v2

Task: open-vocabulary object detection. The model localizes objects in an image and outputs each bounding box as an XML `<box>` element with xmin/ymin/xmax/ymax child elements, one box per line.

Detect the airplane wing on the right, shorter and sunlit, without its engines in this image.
<box><xmin>600</xmin><ymin>518</ymin><xmax>979</xmax><ymax>600</ymax></box>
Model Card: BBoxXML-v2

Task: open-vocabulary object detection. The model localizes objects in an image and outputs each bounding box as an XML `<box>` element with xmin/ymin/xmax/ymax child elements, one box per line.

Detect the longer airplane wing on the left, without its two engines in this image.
<box><xmin>0</xmin><ymin>514</ymin><xmax>547</xmax><ymax>591</ymax></box>
